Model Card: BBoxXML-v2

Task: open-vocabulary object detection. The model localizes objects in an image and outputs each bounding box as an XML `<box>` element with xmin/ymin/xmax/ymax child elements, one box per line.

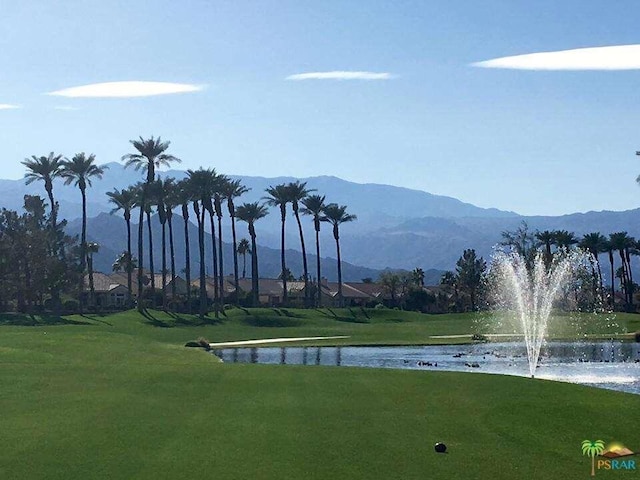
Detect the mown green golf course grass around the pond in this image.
<box><xmin>0</xmin><ymin>309</ymin><xmax>640</xmax><ymax>480</ymax></box>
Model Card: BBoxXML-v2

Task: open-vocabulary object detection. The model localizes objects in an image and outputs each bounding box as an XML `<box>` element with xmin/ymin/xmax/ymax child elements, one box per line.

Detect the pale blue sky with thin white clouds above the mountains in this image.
<box><xmin>0</xmin><ymin>0</ymin><xmax>640</xmax><ymax>215</ymax></box>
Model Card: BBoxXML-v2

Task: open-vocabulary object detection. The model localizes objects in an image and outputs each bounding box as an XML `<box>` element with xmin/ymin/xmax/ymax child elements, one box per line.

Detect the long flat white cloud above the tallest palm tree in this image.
<box><xmin>47</xmin><ymin>81</ymin><xmax>205</xmax><ymax>98</ymax></box>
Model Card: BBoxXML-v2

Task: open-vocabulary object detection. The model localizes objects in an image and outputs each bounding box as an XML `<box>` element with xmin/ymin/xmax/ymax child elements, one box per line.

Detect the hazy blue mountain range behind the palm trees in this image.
<box><xmin>0</xmin><ymin>162</ymin><xmax>640</xmax><ymax>283</ymax></box>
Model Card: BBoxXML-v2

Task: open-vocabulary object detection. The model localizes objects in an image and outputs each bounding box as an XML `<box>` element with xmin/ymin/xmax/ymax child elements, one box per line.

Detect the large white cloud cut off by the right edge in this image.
<box><xmin>471</xmin><ymin>45</ymin><xmax>640</xmax><ymax>70</ymax></box>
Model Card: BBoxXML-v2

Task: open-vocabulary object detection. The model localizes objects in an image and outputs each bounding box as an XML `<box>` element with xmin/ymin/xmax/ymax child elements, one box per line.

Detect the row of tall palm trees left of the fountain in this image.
<box><xmin>23</xmin><ymin>137</ymin><xmax>356</xmax><ymax>315</ymax></box>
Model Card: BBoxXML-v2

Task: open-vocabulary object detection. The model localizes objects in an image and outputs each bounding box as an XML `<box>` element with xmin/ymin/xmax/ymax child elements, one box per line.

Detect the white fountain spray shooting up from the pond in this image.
<box><xmin>489</xmin><ymin>251</ymin><xmax>589</xmax><ymax>378</ymax></box>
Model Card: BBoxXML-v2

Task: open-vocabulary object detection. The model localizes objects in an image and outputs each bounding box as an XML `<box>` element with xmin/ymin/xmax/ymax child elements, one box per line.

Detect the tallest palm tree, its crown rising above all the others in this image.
<box><xmin>122</xmin><ymin>136</ymin><xmax>180</xmax><ymax>311</ymax></box>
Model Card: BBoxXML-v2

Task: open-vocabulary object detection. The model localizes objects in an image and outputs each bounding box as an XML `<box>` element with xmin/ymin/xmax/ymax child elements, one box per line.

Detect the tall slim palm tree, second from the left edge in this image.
<box><xmin>60</xmin><ymin>152</ymin><xmax>108</xmax><ymax>312</ymax></box>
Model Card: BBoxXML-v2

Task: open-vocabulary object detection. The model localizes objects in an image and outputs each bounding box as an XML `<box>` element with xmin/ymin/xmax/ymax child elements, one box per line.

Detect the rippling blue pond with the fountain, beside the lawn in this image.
<box><xmin>213</xmin><ymin>342</ymin><xmax>640</xmax><ymax>394</ymax></box>
